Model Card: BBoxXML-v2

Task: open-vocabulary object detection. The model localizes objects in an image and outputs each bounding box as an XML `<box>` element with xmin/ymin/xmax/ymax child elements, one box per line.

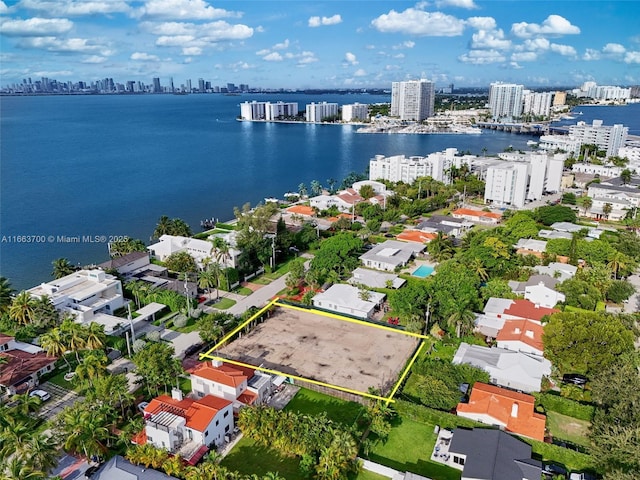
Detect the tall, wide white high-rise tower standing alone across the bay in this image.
<box><xmin>390</xmin><ymin>79</ymin><xmax>435</xmax><ymax>122</ymax></box>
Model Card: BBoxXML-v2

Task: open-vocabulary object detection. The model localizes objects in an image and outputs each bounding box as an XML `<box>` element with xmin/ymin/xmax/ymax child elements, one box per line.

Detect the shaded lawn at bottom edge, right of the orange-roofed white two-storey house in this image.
<box><xmin>221</xmin><ymin>437</ymin><xmax>305</xmax><ymax>480</ymax></box>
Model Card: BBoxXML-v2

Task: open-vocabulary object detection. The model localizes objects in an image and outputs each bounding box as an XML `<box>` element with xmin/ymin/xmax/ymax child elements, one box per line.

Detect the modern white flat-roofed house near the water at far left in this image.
<box><xmin>27</xmin><ymin>269</ymin><xmax>126</xmax><ymax>323</ymax></box>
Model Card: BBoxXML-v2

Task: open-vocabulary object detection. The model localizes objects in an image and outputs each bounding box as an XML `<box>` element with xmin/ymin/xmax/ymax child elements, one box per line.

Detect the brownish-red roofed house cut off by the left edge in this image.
<box><xmin>0</xmin><ymin>333</ymin><xmax>57</xmax><ymax>396</ymax></box>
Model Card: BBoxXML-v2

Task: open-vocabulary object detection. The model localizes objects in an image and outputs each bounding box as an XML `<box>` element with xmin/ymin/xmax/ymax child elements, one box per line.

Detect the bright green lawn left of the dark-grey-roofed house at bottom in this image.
<box><xmin>369</xmin><ymin>417</ymin><xmax>461</xmax><ymax>480</ymax></box>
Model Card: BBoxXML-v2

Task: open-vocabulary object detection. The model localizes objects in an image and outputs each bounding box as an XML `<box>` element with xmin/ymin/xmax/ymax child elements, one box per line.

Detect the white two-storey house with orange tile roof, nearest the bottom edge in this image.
<box><xmin>138</xmin><ymin>389</ymin><xmax>233</xmax><ymax>464</ymax></box>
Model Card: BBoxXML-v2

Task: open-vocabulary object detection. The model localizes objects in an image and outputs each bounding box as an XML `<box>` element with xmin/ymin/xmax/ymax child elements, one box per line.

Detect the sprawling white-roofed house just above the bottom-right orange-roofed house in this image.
<box><xmin>452</xmin><ymin>342</ymin><xmax>551</xmax><ymax>393</ymax></box>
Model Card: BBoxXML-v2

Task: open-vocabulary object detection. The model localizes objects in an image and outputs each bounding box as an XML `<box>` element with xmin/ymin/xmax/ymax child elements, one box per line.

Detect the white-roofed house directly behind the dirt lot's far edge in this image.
<box><xmin>312</xmin><ymin>283</ymin><xmax>385</xmax><ymax>319</ymax></box>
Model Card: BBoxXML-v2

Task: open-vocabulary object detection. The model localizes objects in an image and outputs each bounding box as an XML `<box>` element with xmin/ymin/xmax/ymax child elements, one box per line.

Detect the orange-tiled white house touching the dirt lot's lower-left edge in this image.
<box><xmin>189</xmin><ymin>360</ymin><xmax>273</xmax><ymax>413</ymax></box>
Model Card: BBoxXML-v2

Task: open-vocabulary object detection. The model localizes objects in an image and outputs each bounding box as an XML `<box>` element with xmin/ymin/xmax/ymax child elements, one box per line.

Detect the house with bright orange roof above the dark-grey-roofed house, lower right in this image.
<box><xmin>456</xmin><ymin>382</ymin><xmax>546</xmax><ymax>441</ymax></box>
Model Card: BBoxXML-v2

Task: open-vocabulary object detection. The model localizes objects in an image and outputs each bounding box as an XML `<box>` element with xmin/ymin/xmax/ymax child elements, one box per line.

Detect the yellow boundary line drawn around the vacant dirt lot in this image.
<box><xmin>200</xmin><ymin>298</ymin><xmax>429</xmax><ymax>405</ymax></box>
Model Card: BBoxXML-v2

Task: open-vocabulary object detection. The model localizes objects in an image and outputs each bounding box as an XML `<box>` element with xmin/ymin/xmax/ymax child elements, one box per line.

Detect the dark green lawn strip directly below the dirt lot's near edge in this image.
<box><xmin>285</xmin><ymin>388</ymin><xmax>364</xmax><ymax>426</ymax></box>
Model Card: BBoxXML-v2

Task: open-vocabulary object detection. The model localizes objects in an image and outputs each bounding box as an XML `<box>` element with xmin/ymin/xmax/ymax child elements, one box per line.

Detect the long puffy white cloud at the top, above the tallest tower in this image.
<box><xmin>371</xmin><ymin>8</ymin><xmax>465</xmax><ymax>37</ymax></box>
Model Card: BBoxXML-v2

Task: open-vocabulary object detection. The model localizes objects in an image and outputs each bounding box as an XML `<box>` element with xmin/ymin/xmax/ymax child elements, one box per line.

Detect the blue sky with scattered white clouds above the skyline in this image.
<box><xmin>0</xmin><ymin>0</ymin><xmax>640</xmax><ymax>88</ymax></box>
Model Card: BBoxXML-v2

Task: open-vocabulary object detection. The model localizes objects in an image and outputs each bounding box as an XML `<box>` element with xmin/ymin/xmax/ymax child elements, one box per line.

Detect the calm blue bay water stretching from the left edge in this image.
<box><xmin>0</xmin><ymin>95</ymin><xmax>628</xmax><ymax>288</ymax></box>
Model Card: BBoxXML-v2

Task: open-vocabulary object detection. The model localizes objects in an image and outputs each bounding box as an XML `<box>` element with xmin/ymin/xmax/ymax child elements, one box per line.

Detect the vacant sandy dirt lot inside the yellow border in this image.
<box><xmin>212</xmin><ymin>307</ymin><xmax>418</xmax><ymax>394</ymax></box>
